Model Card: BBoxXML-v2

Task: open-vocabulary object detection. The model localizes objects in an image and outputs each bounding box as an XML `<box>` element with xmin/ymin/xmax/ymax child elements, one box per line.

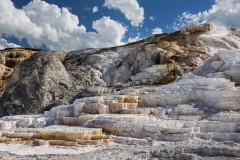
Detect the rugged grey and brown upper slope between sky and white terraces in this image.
<box><xmin>0</xmin><ymin>24</ymin><xmax>240</xmax><ymax>116</ymax></box>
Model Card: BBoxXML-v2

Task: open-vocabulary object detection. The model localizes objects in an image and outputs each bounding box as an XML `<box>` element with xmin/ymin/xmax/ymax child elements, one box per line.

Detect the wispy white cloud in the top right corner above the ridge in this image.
<box><xmin>174</xmin><ymin>0</ymin><xmax>240</xmax><ymax>30</ymax></box>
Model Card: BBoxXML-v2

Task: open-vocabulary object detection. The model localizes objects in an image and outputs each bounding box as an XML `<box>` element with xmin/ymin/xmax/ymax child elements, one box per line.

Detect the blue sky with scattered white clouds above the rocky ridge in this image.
<box><xmin>0</xmin><ymin>0</ymin><xmax>240</xmax><ymax>51</ymax></box>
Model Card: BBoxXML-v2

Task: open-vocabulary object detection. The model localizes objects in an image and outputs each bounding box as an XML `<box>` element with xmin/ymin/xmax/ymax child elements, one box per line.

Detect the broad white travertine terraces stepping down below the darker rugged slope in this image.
<box><xmin>0</xmin><ymin>74</ymin><xmax>240</xmax><ymax>144</ymax></box>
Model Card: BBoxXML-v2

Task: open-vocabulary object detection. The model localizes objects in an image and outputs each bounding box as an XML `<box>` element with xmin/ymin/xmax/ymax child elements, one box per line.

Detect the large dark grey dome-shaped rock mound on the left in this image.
<box><xmin>0</xmin><ymin>51</ymin><xmax>72</xmax><ymax>116</ymax></box>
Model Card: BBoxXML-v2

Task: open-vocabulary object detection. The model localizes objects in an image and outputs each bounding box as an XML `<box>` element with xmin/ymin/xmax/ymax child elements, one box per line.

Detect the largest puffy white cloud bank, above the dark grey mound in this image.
<box><xmin>0</xmin><ymin>0</ymin><xmax>127</xmax><ymax>51</ymax></box>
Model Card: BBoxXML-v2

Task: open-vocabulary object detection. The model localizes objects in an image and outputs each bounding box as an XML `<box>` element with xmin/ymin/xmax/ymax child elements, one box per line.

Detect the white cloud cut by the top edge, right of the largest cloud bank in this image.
<box><xmin>103</xmin><ymin>0</ymin><xmax>144</xmax><ymax>26</ymax></box>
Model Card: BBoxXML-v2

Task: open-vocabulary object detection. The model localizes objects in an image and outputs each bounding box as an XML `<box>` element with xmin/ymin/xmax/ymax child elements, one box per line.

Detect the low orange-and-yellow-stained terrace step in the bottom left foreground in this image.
<box><xmin>0</xmin><ymin>125</ymin><xmax>114</xmax><ymax>146</ymax></box>
